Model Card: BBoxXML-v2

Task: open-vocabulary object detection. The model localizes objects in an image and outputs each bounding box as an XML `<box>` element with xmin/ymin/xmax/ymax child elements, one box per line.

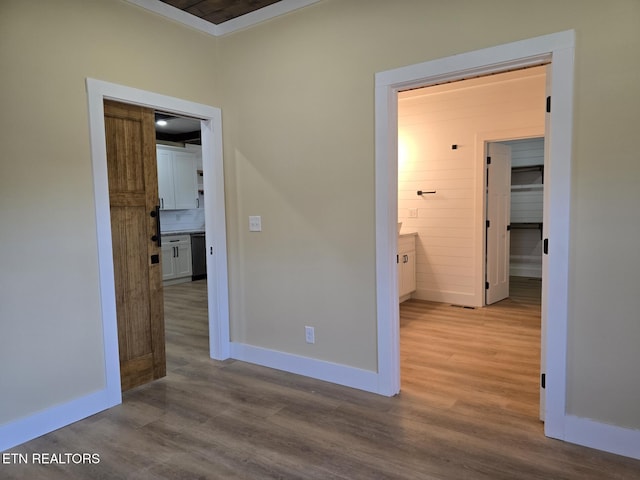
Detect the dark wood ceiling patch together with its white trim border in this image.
<box><xmin>127</xmin><ymin>0</ymin><xmax>320</xmax><ymax>36</ymax></box>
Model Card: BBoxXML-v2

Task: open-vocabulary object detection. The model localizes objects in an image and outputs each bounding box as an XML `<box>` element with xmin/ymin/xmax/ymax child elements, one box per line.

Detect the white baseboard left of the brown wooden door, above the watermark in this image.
<box><xmin>0</xmin><ymin>389</ymin><xmax>119</xmax><ymax>451</ymax></box>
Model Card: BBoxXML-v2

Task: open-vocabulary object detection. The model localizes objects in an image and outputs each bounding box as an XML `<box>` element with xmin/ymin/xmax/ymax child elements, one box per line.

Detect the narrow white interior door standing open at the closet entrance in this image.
<box><xmin>485</xmin><ymin>143</ymin><xmax>511</xmax><ymax>305</ymax></box>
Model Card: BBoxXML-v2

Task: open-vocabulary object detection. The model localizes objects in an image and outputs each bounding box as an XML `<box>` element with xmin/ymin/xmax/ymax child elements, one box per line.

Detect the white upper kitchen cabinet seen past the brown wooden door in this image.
<box><xmin>156</xmin><ymin>145</ymin><xmax>200</xmax><ymax>210</ymax></box>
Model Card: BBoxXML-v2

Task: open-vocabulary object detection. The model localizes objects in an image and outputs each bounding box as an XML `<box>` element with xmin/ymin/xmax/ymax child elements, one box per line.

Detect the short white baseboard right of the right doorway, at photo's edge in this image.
<box><xmin>564</xmin><ymin>415</ymin><xmax>640</xmax><ymax>460</ymax></box>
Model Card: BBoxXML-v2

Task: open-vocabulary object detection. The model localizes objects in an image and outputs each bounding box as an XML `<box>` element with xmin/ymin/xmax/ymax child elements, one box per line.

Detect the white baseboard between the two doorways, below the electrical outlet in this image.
<box><xmin>231</xmin><ymin>342</ymin><xmax>380</xmax><ymax>393</ymax></box>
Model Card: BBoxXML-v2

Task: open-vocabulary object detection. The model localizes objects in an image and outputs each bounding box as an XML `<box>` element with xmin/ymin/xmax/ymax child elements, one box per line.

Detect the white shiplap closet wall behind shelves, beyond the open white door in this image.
<box><xmin>502</xmin><ymin>138</ymin><xmax>544</xmax><ymax>278</ymax></box>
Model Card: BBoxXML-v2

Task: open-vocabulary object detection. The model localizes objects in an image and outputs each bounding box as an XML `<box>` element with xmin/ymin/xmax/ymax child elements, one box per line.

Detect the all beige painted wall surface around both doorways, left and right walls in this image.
<box><xmin>0</xmin><ymin>0</ymin><xmax>640</xmax><ymax>436</ymax></box>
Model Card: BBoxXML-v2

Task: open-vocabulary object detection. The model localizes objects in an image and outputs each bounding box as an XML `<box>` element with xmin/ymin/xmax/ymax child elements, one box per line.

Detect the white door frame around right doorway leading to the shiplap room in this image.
<box><xmin>375</xmin><ymin>30</ymin><xmax>575</xmax><ymax>439</ymax></box>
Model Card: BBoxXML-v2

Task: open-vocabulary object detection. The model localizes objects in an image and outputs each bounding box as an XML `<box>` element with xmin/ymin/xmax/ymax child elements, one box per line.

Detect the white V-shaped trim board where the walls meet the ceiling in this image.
<box><xmin>126</xmin><ymin>0</ymin><xmax>320</xmax><ymax>37</ymax></box>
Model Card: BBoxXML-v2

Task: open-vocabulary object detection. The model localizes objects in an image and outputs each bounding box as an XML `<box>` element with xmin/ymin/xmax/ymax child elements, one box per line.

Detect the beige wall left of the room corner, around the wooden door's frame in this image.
<box><xmin>0</xmin><ymin>0</ymin><xmax>217</xmax><ymax>425</ymax></box>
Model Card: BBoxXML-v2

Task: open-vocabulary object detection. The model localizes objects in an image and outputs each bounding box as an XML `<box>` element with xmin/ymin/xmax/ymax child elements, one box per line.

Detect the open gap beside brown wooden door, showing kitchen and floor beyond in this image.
<box><xmin>155</xmin><ymin>110</ymin><xmax>209</xmax><ymax>375</ymax></box>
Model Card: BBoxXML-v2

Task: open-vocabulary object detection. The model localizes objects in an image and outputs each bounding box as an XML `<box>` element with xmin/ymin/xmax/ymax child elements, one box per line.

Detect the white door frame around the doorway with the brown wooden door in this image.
<box><xmin>87</xmin><ymin>78</ymin><xmax>230</xmax><ymax>408</ymax></box>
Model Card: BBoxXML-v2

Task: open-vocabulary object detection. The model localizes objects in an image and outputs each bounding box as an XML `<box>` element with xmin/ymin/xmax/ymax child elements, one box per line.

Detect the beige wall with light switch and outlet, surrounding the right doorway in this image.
<box><xmin>220</xmin><ymin>0</ymin><xmax>640</xmax><ymax>428</ymax></box>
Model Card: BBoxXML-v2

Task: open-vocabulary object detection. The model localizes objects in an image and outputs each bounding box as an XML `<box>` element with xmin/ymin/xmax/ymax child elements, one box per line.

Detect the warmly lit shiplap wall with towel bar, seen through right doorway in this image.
<box><xmin>398</xmin><ymin>67</ymin><xmax>545</xmax><ymax>306</ymax></box>
